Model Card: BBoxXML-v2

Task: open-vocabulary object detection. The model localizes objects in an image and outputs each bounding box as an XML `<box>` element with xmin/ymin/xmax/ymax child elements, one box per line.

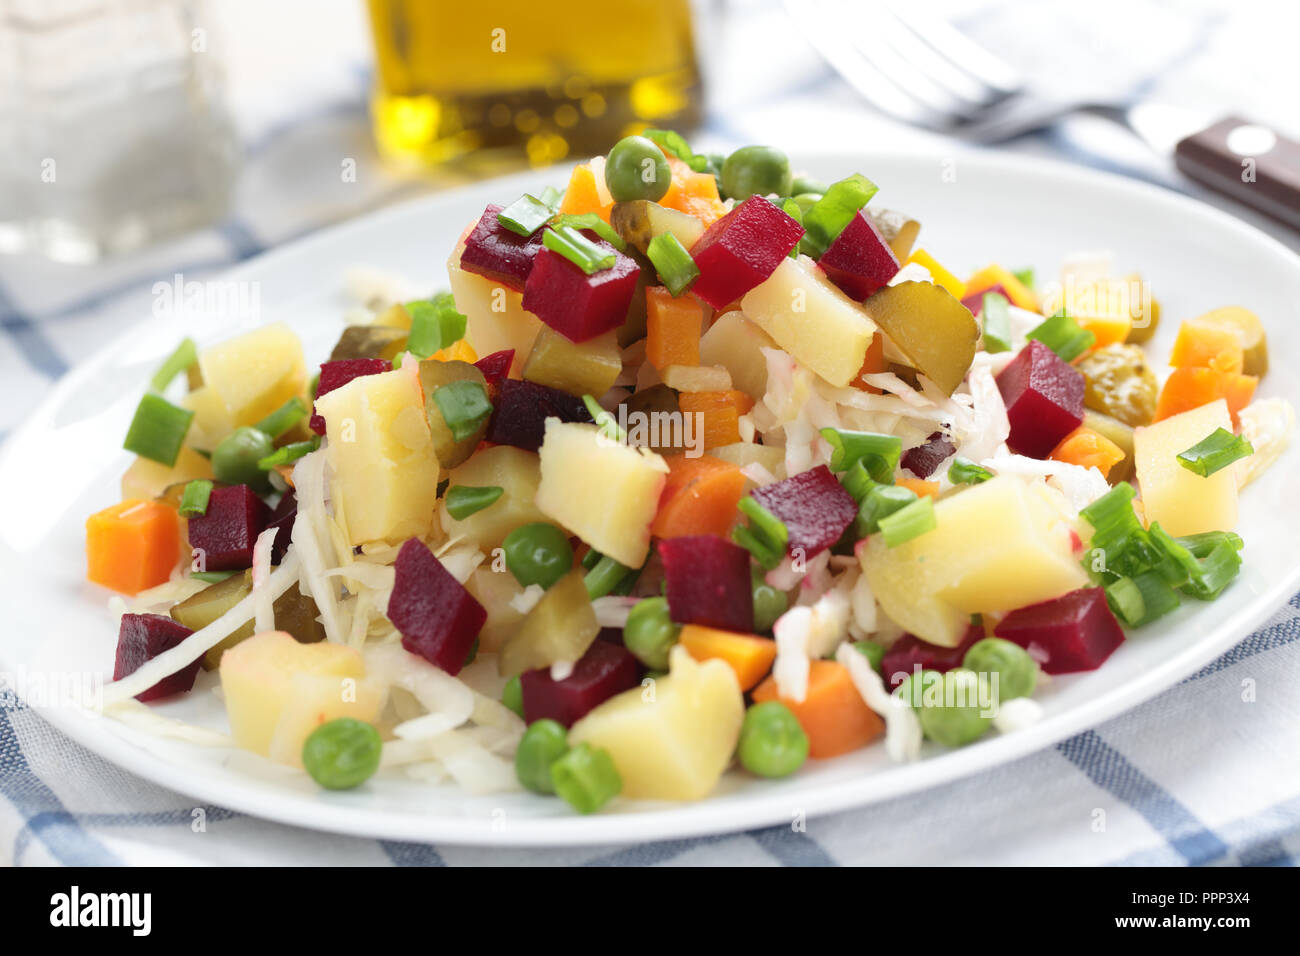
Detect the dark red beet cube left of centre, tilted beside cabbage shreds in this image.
<box><xmin>389</xmin><ymin>537</ymin><xmax>488</xmax><ymax>675</ymax></box>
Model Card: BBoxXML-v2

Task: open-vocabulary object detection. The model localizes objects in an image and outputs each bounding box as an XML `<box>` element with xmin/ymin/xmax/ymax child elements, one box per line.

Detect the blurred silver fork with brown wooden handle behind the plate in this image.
<box><xmin>784</xmin><ymin>0</ymin><xmax>1300</xmax><ymax>229</ymax></box>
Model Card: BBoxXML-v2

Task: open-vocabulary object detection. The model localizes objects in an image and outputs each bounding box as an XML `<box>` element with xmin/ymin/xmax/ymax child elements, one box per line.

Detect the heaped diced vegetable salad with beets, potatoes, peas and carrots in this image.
<box><xmin>86</xmin><ymin>130</ymin><xmax>1295</xmax><ymax>813</ymax></box>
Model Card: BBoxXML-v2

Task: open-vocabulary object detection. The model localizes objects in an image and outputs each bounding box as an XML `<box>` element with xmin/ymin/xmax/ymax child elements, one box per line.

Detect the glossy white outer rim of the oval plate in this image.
<box><xmin>10</xmin><ymin>147</ymin><xmax>1300</xmax><ymax>847</ymax></box>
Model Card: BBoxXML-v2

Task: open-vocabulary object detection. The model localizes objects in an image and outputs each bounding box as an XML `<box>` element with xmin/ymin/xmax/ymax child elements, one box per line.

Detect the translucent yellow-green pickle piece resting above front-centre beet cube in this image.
<box><xmin>497</xmin><ymin>567</ymin><xmax>601</xmax><ymax>678</ymax></box>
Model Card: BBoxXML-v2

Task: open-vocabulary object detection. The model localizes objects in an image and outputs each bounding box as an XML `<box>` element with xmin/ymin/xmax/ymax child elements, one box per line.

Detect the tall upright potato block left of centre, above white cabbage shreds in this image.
<box><xmin>316</xmin><ymin>362</ymin><xmax>438</xmax><ymax>545</ymax></box>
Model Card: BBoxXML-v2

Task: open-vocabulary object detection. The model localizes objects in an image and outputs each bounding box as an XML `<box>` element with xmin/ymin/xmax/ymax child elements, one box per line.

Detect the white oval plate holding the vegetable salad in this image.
<box><xmin>0</xmin><ymin>153</ymin><xmax>1300</xmax><ymax>845</ymax></box>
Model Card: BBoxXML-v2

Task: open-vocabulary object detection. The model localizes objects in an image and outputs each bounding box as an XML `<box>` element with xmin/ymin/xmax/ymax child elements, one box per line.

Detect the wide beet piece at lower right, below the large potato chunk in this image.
<box><xmin>993</xmin><ymin>588</ymin><xmax>1125</xmax><ymax>674</ymax></box>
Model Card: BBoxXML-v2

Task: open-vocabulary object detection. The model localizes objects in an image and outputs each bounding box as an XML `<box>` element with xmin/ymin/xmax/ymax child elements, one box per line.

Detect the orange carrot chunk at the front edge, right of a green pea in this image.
<box><xmin>754</xmin><ymin>661</ymin><xmax>885</xmax><ymax>757</ymax></box>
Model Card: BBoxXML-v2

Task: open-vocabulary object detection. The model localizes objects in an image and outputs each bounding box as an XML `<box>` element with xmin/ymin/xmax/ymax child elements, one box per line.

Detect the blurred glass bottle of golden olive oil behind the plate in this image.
<box><xmin>369</xmin><ymin>0</ymin><xmax>699</xmax><ymax>168</ymax></box>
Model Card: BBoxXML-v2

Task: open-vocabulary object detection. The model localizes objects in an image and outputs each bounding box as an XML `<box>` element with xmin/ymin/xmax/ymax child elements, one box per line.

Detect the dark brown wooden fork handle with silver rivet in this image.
<box><xmin>1174</xmin><ymin>116</ymin><xmax>1300</xmax><ymax>229</ymax></box>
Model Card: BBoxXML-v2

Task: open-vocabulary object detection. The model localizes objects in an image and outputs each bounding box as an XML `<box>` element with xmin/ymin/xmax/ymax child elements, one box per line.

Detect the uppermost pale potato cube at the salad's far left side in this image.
<box><xmin>199</xmin><ymin>323</ymin><xmax>307</xmax><ymax>427</ymax></box>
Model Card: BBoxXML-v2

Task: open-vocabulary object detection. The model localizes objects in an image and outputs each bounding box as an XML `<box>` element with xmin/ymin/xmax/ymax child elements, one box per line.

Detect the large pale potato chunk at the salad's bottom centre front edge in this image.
<box><xmin>569</xmin><ymin>645</ymin><xmax>745</xmax><ymax>800</ymax></box>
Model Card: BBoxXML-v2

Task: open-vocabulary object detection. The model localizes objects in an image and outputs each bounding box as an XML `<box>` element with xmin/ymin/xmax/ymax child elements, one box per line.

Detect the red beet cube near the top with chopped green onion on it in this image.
<box><xmin>523</xmin><ymin>230</ymin><xmax>641</xmax><ymax>342</ymax></box>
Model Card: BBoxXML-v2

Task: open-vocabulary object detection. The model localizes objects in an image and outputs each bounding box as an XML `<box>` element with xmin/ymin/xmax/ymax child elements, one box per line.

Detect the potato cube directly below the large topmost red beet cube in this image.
<box><xmin>740</xmin><ymin>256</ymin><xmax>878</xmax><ymax>388</ymax></box>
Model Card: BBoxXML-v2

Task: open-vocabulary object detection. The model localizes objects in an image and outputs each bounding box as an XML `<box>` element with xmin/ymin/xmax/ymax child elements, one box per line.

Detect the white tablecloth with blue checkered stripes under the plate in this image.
<box><xmin>0</xmin><ymin>0</ymin><xmax>1300</xmax><ymax>866</ymax></box>
